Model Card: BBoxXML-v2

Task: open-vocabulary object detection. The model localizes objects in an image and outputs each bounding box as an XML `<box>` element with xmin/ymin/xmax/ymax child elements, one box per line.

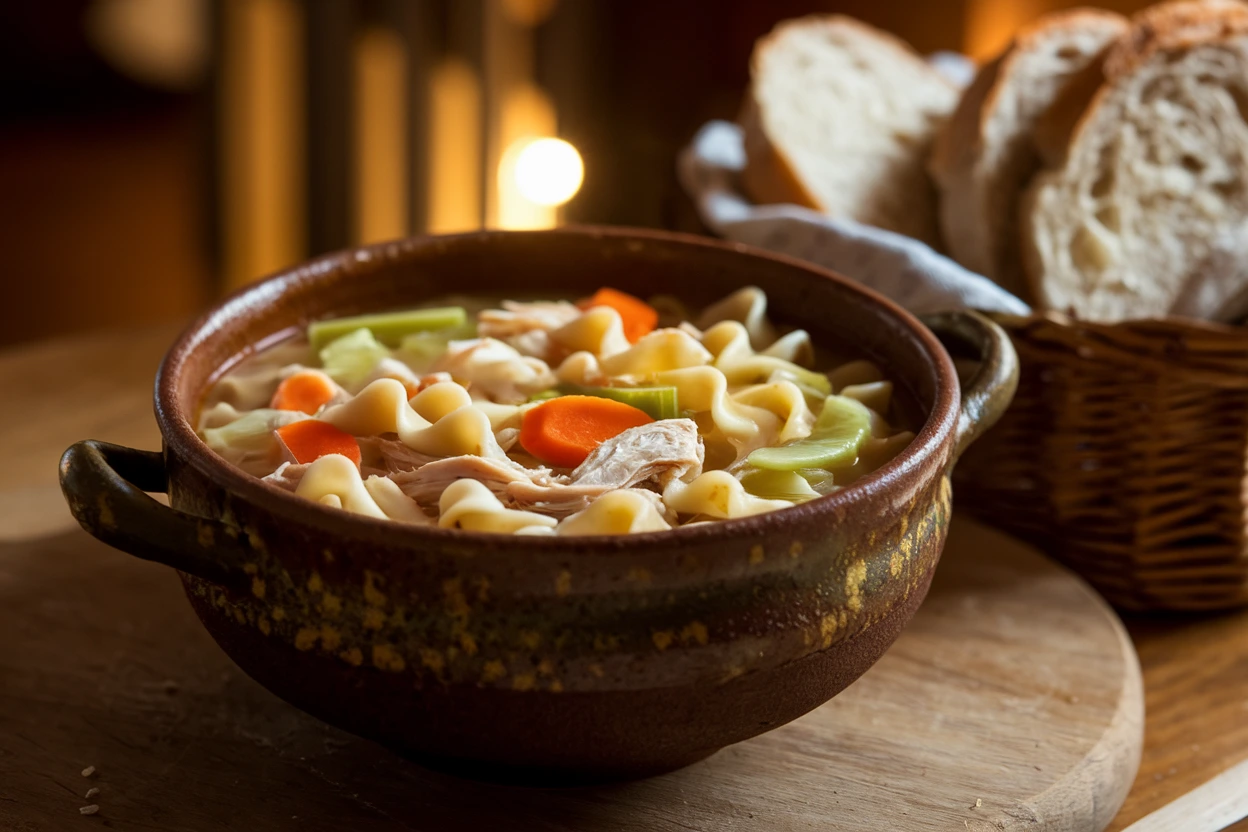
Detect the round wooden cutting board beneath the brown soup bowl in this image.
<box><xmin>0</xmin><ymin>513</ymin><xmax>1142</xmax><ymax>832</ymax></box>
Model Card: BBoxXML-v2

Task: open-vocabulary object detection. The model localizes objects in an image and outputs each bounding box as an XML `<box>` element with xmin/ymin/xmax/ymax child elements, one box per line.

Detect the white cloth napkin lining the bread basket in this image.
<box><xmin>679</xmin><ymin>121</ymin><xmax>1031</xmax><ymax>314</ymax></box>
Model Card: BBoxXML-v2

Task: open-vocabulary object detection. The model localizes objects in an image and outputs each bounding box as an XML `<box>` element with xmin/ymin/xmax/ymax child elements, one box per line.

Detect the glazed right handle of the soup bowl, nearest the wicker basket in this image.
<box><xmin>922</xmin><ymin>311</ymin><xmax>1018</xmax><ymax>462</ymax></box>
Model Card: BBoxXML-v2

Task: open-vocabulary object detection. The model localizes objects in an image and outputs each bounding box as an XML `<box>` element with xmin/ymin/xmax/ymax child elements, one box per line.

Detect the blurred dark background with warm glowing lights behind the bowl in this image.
<box><xmin>0</xmin><ymin>0</ymin><xmax>1146</xmax><ymax>346</ymax></box>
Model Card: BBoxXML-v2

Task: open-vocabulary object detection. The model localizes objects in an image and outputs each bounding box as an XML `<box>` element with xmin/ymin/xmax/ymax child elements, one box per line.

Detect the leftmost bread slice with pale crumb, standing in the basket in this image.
<box><xmin>741</xmin><ymin>15</ymin><xmax>957</xmax><ymax>244</ymax></box>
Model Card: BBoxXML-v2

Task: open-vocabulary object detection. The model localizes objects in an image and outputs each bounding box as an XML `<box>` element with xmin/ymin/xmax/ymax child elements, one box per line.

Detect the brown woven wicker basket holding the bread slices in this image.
<box><xmin>956</xmin><ymin>314</ymin><xmax>1248</xmax><ymax>610</ymax></box>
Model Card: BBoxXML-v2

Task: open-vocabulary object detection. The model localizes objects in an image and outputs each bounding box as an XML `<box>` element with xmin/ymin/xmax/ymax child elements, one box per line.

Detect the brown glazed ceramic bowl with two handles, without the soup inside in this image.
<box><xmin>61</xmin><ymin>227</ymin><xmax>1017</xmax><ymax>782</ymax></box>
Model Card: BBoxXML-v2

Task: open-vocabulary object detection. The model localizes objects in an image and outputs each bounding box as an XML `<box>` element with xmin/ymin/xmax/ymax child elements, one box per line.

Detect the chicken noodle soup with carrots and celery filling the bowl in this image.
<box><xmin>198</xmin><ymin>287</ymin><xmax>914</xmax><ymax>535</ymax></box>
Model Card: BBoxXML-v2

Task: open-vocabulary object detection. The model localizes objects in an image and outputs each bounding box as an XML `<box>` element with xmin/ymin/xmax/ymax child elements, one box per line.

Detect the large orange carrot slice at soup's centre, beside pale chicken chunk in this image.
<box><xmin>520</xmin><ymin>395</ymin><xmax>654</xmax><ymax>468</ymax></box>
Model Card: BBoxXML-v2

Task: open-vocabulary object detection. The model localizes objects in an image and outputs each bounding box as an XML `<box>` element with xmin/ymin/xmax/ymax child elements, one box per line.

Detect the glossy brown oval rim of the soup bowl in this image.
<box><xmin>155</xmin><ymin>225</ymin><xmax>961</xmax><ymax>553</ymax></box>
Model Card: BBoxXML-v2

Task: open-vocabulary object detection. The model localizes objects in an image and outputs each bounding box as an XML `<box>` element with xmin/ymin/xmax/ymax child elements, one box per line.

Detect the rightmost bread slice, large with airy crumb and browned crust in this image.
<box><xmin>1021</xmin><ymin>0</ymin><xmax>1248</xmax><ymax>322</ymax></box>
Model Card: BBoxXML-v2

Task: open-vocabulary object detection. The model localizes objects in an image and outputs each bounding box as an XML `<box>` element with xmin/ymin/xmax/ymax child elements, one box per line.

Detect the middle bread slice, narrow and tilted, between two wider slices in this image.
<box><xmin>930</xmin><ymin>9</ymin><xmax>1128</xmax><ymax>299</ymax></box>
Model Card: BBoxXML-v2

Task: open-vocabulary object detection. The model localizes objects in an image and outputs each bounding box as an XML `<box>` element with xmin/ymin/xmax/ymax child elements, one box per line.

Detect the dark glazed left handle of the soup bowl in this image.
<box><xmin>61</xmin><ymin>439</ymin><xmax>253</xmax><ymax>586</ymax></box>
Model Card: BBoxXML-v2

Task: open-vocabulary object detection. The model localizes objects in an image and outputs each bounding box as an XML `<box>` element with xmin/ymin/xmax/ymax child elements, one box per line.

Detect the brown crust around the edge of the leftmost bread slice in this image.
<box><xmin>739</xmin><ymin>14</ymin><xmax>957</xmax><ymax>244</ymax></box>
